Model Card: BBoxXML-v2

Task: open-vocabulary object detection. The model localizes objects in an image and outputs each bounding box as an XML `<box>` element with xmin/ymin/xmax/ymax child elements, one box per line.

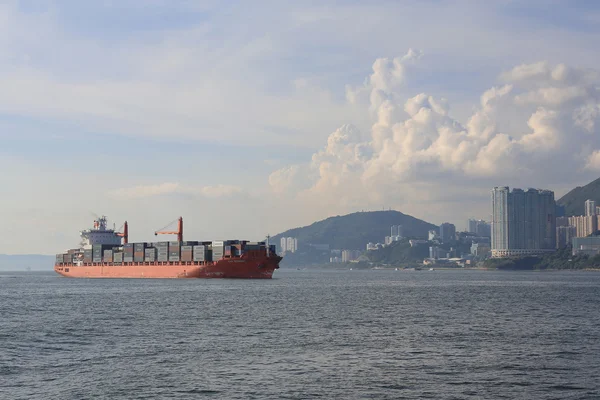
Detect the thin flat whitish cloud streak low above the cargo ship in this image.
<box><xmin>111</xmin><ymin>182</ymin><xmax>243</xmax><ymax>200</ymax></box>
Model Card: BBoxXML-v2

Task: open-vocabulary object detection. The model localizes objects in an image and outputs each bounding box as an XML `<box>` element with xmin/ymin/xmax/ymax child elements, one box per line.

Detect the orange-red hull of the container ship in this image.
<box><xmin>54</xmin><ymin>256</ymin><xmax>281</xmax><ymax>279</ymax></box>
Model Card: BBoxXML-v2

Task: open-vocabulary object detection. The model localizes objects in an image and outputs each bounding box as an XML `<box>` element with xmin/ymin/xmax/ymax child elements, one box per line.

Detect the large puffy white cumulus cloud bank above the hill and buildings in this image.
<box><xmin>270</xmin><ymin>50</ymin><xmax>600</xmax><ymax>220</ymax></box>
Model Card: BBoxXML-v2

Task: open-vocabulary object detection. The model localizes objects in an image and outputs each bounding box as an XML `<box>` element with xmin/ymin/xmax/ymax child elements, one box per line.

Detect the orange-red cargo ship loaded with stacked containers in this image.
<box><xmin>54</xmin><ymin>216</ymin><xmax>282</xmax><ymax>279</ymax></box>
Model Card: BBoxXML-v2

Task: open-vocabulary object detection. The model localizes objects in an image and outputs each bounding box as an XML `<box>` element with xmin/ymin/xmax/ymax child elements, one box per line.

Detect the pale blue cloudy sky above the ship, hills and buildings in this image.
<box><xmin>0</xmin><ymin>0</ymin><xmax>600</xmax><ymax>254</ymax></box>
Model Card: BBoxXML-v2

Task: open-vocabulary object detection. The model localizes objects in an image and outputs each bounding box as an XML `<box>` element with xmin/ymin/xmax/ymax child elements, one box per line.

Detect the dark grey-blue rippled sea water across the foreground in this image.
<box><xmin>0</xmin><ymin>270</ymin><xmax>600</xmax><ymax>399</ymax></box>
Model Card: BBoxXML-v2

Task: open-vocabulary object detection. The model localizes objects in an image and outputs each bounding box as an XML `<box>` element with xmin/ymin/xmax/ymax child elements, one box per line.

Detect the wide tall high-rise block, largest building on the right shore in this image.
<box><xmin>491</xmin><ymin>186</ymin><xmax>556</xmax><ymax>257</ymax></box>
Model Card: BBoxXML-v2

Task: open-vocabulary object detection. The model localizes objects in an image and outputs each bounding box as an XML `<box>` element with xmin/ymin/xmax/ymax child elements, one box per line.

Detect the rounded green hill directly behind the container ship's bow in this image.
<box><xmin>271</xmin><ymin>211</ymin><xmax>438</xmax><ymax>250</ymax></box>
